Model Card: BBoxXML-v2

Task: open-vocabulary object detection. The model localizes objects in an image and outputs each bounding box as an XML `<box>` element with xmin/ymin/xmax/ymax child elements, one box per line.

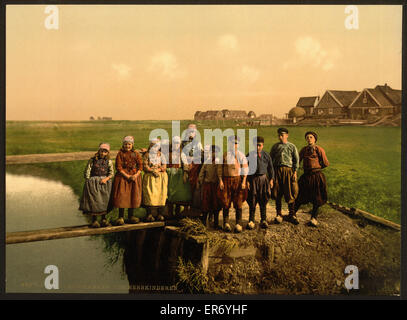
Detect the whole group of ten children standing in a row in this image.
<box><xmin>80</xmin><ymin>124</ymin><xmax>329</xmax><ymax>232</ymax></box>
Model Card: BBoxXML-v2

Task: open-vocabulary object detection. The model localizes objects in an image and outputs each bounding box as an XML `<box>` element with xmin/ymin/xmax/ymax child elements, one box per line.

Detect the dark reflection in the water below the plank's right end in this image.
<box><xmin>123</xmin><ymin>229</ymin><xmax>208</xmax><ymax>293</ymax></box>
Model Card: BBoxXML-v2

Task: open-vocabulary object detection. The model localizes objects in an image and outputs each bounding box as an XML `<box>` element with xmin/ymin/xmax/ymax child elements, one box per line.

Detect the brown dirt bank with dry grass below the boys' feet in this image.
<box><xmin>198</xmin><ymin>206</ymin><xmax>400</xmax><ymax>295</ymax></box>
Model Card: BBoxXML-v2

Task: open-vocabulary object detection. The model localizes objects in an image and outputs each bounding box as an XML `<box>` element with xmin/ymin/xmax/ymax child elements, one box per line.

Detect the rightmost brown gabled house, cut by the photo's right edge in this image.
<box><xmin>349</xmin><ymin>84</ymin><xmax>401</xmax><ymax>120</ymax></box>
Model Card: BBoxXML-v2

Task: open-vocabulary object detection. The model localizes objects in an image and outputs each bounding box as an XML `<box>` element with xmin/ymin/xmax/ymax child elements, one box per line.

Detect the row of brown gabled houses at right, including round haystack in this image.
<box><xmin>288</xmin><ymin>84</ymin><xmax>401</xmax><ymax>120</ymax></box>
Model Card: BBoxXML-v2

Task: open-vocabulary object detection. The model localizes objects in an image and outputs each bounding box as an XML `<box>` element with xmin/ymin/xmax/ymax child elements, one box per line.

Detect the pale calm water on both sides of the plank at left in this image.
<box><xmin>6</xmin><ymin>173</ymin><xmax>129</xmax><ymax>293</ymax></box>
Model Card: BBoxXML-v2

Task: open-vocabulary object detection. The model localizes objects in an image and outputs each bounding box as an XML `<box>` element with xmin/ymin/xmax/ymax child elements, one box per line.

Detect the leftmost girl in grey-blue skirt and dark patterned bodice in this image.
<box><xmin>79</xmin><ymin>142</ymin><xmax>113</xmax><ymax>228</ymax></box>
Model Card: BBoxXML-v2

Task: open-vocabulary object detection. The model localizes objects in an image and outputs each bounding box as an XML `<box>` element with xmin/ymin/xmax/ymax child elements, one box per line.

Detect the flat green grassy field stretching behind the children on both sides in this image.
<box><xmin>6</xmin><ymin>121</ymin><xmax>401</xmax><ymax>223</ymax></box>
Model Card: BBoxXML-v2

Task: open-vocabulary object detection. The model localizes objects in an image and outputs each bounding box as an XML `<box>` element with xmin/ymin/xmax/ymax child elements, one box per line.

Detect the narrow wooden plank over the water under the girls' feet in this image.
<box><xmin>6</xmin><ymin>222</ymin><xmax>165</xmax><ymax>244</ymax></box>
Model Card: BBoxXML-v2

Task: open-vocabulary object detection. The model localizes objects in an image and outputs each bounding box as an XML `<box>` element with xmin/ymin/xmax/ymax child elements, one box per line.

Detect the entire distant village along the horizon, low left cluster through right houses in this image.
<box><xmin>194</xmin><ymin>84</ymin><xmax>402</xmax><ymax>126</ymax></box>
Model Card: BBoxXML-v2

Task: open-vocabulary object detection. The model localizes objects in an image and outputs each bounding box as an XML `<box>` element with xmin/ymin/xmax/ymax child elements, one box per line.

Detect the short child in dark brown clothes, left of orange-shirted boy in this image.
<box><xmin>198</xmin><ymin>145</ymin><xmax>222</xmax><ymax>229</ymax></box>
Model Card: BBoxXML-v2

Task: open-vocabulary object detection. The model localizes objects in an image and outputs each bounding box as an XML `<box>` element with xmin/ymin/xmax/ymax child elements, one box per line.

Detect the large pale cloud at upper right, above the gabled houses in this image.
<box><xmin>283</xmin><ymin>36</ymin><xmax>341</xmax><ymax>71</ymax></box>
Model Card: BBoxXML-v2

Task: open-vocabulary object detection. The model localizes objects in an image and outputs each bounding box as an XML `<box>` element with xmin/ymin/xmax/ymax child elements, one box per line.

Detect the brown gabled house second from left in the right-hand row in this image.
<box><xmin>314</xmin><ymin>90</ymin><xmax>359</xmax><ymax>119</ymax></box>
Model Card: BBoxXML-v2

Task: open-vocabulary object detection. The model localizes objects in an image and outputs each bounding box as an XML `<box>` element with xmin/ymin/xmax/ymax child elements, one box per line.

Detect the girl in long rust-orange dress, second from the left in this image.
<box><xmin>113</xmin><ymin>136</ymin><xmax>143</xmax><ymax>225</ymax></box>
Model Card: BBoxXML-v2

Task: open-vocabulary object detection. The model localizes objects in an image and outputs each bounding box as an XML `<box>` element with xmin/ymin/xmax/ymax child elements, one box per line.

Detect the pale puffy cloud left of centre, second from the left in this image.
<box><xmin>149</xmin><ymin>51</ymin><xmax>187</xmax><ymax>80</ymax></box>
